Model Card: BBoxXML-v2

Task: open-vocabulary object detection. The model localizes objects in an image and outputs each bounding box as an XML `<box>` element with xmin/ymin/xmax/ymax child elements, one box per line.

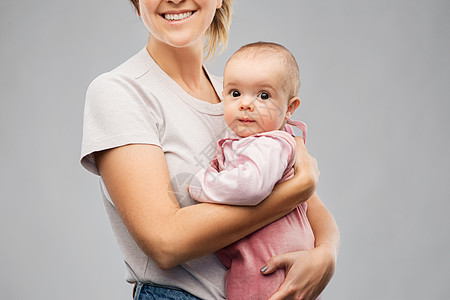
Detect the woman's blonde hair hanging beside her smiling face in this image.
<box><xmin>126</xmin><ymin>0</ymin><xmax>233</xmax><ymax>59</ymax></box>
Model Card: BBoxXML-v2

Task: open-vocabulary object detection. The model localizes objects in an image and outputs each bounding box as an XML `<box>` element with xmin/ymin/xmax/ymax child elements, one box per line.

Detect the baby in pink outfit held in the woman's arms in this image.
<box><xmin>189</xmin><ymin>42</ymin><xmax>314</xmax><ymax>300</ymax></box>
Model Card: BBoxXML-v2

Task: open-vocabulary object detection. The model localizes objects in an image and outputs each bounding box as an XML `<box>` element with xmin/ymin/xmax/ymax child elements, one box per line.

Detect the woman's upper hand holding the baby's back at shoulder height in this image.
<box><xmin>294</xmin><ymin>136</ymin><xmax>320</xmax><ymax>190</ymax></box>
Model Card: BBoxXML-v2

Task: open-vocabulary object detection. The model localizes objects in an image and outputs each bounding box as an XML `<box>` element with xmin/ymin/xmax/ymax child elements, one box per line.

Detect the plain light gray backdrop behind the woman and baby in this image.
<box><xmin>0</xmin><ymin>0</ymin><xmax>450</xmax><ymax>299</ymax></box>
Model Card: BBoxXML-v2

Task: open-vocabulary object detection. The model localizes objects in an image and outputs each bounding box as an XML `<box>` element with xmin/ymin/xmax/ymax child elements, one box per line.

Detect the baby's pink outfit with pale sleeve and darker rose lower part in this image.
<box><xmin>189</xmin><ymin>120</ymin><xmax>314</xmax><ymax>300</ymax></box>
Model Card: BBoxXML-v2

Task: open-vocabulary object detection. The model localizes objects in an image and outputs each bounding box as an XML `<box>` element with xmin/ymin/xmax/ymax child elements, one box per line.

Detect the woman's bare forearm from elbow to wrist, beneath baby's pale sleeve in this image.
<box><xmin>160</xmin><ymin>172</ymin><xmax>314</xmax><ymax>267</ymax></box>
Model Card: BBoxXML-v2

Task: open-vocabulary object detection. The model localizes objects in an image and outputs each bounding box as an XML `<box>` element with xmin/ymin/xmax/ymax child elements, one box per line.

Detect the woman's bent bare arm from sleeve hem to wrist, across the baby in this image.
<box><xmin>95</xmin><ymin>141</ymin><xmax>318</xmax><ymax>269</ymax></box>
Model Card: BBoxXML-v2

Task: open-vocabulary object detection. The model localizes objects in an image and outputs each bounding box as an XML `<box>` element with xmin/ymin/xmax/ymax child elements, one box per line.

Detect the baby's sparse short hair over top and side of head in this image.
<box><xmin>227</xmin><ymin>42</ymin><xmax>300</xmax><ymax>99</ymax></box>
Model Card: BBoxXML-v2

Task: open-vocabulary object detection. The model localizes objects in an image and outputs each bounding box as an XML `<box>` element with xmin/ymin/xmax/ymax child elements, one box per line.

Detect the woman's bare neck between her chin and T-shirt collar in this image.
<box><xmin>147</xmin><ymin>35</ymin><xmax>206</xmax><ymax>91</ymax></box>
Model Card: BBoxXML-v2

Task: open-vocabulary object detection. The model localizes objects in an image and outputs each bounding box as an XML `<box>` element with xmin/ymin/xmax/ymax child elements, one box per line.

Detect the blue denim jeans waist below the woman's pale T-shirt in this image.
<box><xmin>133</xmin><ymin>282</ymin><xmax>200</xmax><ymax>300</ymax></box>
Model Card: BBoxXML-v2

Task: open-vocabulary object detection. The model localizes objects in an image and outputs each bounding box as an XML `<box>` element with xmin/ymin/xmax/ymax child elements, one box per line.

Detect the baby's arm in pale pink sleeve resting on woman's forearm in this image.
<box><xmin>189</xmin><ymin>136</ymin><xmax>295</xmax><ymax>205</ymax></box>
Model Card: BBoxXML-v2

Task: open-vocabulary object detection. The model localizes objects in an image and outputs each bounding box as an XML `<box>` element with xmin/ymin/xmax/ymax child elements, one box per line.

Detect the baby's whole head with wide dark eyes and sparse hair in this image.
<box><xmin>223</xmin><ymin>42</ymin><xmax>300</xmax><ymax>137</ymax></box>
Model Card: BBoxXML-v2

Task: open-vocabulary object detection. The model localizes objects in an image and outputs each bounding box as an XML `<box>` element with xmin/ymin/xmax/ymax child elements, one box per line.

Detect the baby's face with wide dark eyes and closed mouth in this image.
<box><xmin>223</xmin><ymin>57</ymin><xmax>289</xmax><ymax>137</ymax></box>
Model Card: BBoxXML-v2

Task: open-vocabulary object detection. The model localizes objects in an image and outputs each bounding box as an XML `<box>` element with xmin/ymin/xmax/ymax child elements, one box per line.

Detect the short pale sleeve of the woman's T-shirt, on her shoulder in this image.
<box><xmin>81</xmin><ymin>73</ymin><xmax>161</xmax><ymax>175</ymax></box>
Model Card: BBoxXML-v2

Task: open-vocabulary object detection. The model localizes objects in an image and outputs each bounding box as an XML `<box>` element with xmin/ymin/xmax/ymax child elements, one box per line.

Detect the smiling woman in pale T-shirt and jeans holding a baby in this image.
<box><xmin>81</xmin><ymin>0</ymin><xmax>339</xmax><ymax>299</ymax></box>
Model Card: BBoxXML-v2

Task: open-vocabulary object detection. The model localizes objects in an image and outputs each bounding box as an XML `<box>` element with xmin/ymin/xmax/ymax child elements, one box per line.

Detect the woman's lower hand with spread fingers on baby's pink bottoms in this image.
<box><xmin>262</xmin><ymin>245</ymin><xmax>336</xmax><ymax>300</ymax></box>
